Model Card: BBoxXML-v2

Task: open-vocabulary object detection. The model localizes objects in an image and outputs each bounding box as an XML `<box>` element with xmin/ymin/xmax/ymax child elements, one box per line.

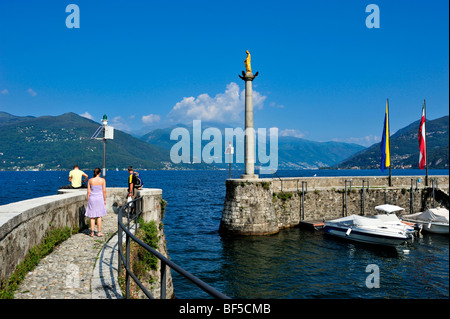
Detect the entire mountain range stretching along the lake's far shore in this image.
<box><xmin>0</xmin><ymin>112</ymin><xmax>449</xmax><ymax>170</ymax></box>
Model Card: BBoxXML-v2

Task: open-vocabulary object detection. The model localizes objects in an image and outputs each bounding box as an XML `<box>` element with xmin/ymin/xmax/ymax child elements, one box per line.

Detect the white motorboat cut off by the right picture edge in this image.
<box><xmin>403</xmin><ymin>208</ymin><xmax>448</xmax><ymax>235</ymax></box>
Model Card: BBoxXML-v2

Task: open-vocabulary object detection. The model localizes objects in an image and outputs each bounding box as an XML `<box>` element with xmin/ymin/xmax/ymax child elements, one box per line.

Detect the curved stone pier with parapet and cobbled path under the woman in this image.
<box><xmin>0</xmin><ymin>188</ymin><xmax>173</xmax><ymax>299</ymax></box>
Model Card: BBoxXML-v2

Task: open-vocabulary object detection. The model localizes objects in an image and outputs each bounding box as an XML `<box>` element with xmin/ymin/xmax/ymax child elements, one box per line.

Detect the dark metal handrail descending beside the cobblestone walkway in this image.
<box><xmin>118</xmin><ymin>197</ymin><xmax>230</xmax><ymax>299</ymax></box>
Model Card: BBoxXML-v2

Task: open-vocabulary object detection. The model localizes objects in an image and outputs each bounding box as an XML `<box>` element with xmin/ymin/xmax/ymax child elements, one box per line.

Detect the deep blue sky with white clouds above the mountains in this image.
<box><xmin>0</xmin><ymin>0</ymin><xmax>449</xmax><ymax>146</ymax></box>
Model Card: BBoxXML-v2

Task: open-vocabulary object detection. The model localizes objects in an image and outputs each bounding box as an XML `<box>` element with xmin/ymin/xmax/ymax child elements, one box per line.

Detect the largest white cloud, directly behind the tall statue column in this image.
<box><xmin>168</xmin><ymin>82</ymin><xmax>266</xmax><ymax>122</ymax></box>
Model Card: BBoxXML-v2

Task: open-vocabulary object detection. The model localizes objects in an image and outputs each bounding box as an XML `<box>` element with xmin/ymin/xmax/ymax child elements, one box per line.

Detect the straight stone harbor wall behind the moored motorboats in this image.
<box><xmin>219</xmin><ymin>176</ymin><xmax>449</xmax><ymax>235</ymax></box>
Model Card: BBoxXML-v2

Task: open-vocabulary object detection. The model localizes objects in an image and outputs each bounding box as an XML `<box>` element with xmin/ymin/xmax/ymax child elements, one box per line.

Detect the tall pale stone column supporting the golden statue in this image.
<box><xmin>239</xmin><ymin>72</ymin><xmax>258</xmax><ymax>179</ymax></box>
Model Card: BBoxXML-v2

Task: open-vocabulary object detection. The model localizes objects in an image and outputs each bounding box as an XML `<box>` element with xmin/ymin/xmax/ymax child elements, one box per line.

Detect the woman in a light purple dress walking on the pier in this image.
<box><xmin>86</xmin><ymin>168</ymin><xmax>106</xmax><ymax>237</ymax></box>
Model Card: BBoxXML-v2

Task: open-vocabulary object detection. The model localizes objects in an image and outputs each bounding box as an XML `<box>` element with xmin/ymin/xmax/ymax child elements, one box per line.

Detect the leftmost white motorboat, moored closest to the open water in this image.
<box><xmin>324</xmin><ymin>215</ymin><xmax>412</xmax><ymax>246</ymax></box>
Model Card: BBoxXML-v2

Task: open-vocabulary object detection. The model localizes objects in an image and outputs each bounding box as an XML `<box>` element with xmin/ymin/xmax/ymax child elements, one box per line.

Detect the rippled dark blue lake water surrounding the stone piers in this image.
<box><xmin>0</xmin><ymin>170</ymin><xmax>449</xmax><ymax>299</ymax></box>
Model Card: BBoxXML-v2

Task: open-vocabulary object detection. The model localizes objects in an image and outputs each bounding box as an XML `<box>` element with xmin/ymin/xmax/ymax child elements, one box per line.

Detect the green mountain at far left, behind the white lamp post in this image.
<box><xmin>0</xmin><ymin>113</ymin><xmax>170</xmax><ymax>170</ymax></box>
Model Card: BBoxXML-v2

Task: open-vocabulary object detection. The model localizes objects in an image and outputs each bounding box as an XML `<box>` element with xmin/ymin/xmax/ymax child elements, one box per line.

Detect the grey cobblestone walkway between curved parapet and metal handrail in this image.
<box><xmin>14</xmin><ymin>213</ymin><xmax>117</xmax><ymax>299</ymax></box>
